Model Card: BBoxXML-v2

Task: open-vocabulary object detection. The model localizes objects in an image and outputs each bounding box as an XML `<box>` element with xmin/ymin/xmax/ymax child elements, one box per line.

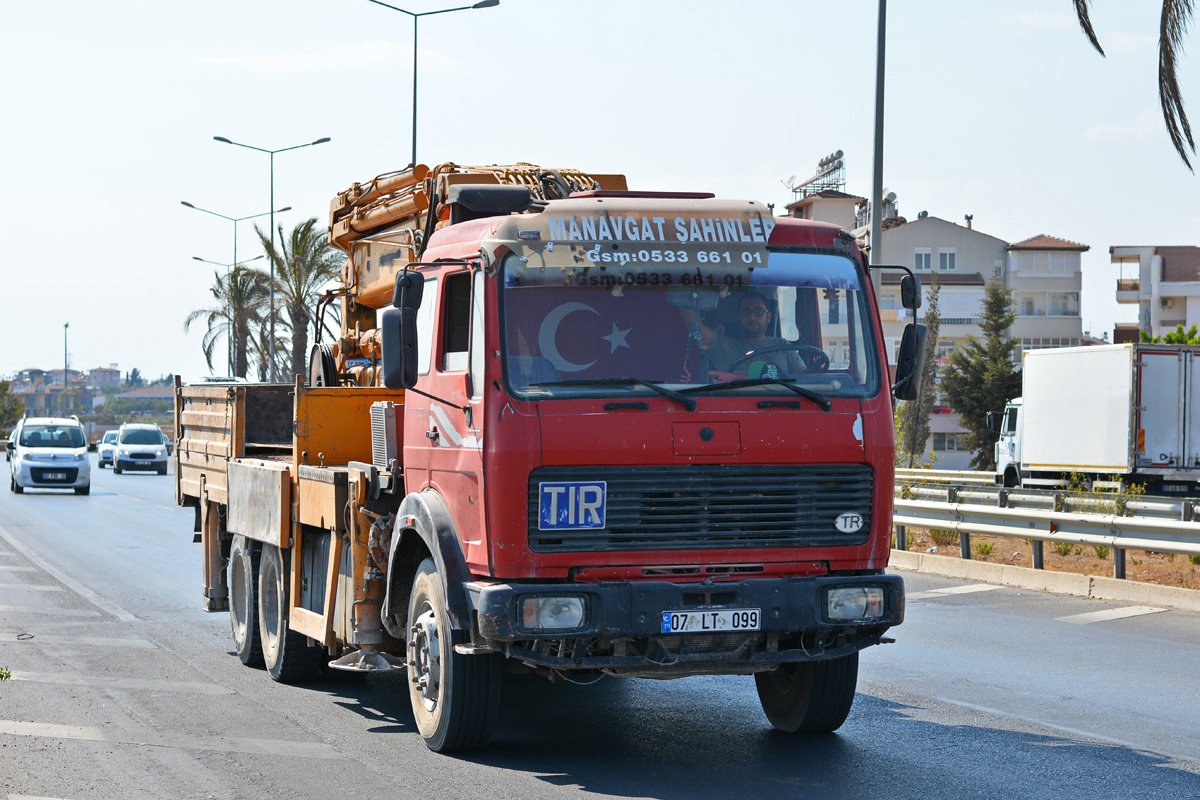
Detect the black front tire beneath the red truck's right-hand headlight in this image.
<box><xmin>754</xmin><ymin>652</ymin><xmax>858</xmax><ymax>733</ymax></box>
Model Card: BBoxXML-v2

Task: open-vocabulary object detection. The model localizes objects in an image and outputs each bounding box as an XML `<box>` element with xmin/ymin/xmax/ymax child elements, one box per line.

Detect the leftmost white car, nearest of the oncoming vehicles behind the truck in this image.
<box><xmin>8</xmin><ymin>416</ymin><xmax>91</xmax><ymax>494</ymax></box>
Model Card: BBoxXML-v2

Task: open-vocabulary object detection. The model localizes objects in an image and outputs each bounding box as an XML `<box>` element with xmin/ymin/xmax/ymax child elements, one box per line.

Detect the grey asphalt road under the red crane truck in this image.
<box><xmin>0</xmin><ymin>456</ymin><xmax>1200</xmax><ymax>800</ymax></box>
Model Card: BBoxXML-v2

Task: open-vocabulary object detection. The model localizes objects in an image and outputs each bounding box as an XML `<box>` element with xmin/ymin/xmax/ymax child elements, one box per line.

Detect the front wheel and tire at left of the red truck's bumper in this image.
<box><xmin>408</xmin><ymin>559</ymin><xmax>504</xmax><ymax>753</ymax></box>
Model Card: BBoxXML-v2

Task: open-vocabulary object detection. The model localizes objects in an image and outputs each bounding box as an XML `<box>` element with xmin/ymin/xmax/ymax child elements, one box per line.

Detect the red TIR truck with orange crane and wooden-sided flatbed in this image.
<box><xmin>175</xmin><ymin>163</ymin><xmax>924</xmax><ymax>752</ymax></box>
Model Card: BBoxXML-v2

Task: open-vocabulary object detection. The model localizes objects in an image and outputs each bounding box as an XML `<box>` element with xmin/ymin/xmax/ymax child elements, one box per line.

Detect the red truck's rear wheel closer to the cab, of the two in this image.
<box><xmin>258</xmin><ymin>545</ymin><xmax>325</xmax><ymax>684</ymax></box>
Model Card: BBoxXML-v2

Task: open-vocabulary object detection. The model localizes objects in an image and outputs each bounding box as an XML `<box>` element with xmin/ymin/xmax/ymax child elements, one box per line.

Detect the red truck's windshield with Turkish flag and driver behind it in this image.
<box><xmin>502</xmin><ymin>246</ymin><xmax>880</xmax><ymax>399</ymax></box>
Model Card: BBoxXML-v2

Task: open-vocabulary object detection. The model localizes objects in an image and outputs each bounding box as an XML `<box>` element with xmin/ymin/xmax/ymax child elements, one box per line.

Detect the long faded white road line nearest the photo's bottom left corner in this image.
<box><xmin>0</xmin><ymin>720</ymin><xmax>342</xmax><ymax>759</ymax></box>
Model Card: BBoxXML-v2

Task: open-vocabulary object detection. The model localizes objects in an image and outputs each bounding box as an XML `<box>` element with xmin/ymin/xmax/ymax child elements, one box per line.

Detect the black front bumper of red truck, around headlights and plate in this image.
<box><xmin>467</xmin><ymin>575</ymin><xmax>905</xmax><ymax>672</ymax></box>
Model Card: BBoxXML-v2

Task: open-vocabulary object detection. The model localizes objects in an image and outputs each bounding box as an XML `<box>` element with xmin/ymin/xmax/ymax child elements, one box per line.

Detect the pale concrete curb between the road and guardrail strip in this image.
<box><xmin>889</xmin><ymin>549</ymin><xmax>1200</xmax><ymax>612</ymax></box>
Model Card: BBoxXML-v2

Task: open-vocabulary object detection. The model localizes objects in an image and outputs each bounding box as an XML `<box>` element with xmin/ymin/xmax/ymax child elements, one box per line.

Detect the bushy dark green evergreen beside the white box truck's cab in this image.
<box><xmin>942</xmin><ymin>281</ymin><xmax>1021</xmax><ymax>469</ymax></box>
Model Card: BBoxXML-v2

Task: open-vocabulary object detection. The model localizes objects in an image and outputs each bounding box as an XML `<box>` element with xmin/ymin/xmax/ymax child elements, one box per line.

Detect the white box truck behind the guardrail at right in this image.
<box><xmin>989</xmin><ymin>343</ymin><xmax>1200</xmax><ymax>494</ymax></box>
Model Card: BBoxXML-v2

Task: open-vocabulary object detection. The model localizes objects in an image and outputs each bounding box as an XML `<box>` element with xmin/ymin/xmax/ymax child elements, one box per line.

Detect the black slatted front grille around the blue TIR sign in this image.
<box><xmin>528</xmin><ymin>464</ymin><xmax>874</xmax><ymax>553</ymax></box>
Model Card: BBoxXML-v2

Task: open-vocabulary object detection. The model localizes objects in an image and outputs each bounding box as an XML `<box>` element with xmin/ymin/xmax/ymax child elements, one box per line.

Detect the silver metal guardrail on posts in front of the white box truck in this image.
<box><xmin>893</xmin><ymin>470</ymin><xmax>1200</xmax><ymax>578</ymax></box>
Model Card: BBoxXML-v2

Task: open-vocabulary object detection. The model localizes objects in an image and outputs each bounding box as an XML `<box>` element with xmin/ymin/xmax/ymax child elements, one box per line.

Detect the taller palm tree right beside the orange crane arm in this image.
<box><xmin>254</xmin><ymin>217</ymin><xmax>342</xmax><ymax>375</ymax></box>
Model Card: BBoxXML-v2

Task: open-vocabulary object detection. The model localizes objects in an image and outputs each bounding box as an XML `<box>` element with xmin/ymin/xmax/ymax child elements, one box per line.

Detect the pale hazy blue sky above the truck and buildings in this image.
<box><xmin>0</xmin><ymin>0</ymin><xmax>1200</xmax><ymax>379</ymax></box>
